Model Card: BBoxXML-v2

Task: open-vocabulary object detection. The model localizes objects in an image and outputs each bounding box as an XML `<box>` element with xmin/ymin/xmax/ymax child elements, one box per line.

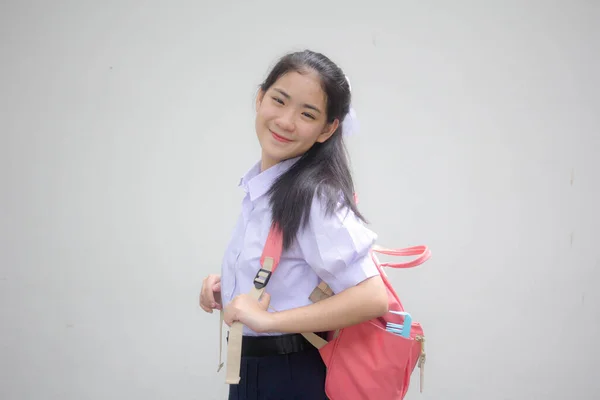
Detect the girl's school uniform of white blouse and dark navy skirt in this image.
<box><xmin>221</xmin><ymin>158</ymin><xmax>378</xmax><ymax>400</ymax></box>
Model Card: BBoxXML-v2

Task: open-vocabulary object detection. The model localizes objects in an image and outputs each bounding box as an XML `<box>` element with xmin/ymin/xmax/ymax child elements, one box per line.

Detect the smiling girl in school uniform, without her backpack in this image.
<box><xmin>200</xmin><ymin>50</ymin><xmax>388</xmax><ymax>400</ymax></box>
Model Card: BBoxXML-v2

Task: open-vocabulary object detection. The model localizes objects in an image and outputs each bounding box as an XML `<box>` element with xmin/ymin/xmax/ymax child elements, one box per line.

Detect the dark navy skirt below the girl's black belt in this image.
<box><xmin>229</xmin><ymin>347</ymin><xmax>327</xmax><ymax>400</ymax></box>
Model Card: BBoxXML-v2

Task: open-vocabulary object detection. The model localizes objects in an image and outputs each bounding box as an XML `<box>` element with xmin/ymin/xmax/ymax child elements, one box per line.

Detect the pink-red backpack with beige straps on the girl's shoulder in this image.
<box><xmin>225</xmin><ymin>225</ymin><xmax>431</xmax><ymax>400</ymax></box>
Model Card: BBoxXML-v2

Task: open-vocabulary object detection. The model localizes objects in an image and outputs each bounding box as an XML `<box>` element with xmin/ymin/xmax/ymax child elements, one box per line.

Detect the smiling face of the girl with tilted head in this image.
<box><xmin>255</xmin><ymin>71</ymin><xmax>339</xmax><ymax>171</ymax></box>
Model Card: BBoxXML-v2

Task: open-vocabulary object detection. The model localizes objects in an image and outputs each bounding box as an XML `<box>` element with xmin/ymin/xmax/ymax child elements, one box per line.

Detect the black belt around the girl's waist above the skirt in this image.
<box><xmin>227</xmin><ymin>333</ymin><xmax>326</xmax><ymax>357</ymax></box>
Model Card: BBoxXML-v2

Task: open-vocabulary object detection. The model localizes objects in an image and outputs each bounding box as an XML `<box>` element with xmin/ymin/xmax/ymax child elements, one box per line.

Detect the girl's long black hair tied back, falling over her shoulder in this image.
<box><xmin>260</xmin><ymin>50</ymin><xmax>366</xmax><ymax>249</ymax></box>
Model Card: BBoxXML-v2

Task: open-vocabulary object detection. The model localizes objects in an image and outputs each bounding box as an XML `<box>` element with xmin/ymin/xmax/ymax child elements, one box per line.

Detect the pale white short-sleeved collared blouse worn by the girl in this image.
<box><xmin>221</xmin><ymin>158</ymin><xmax>379</xmax><ymax>335</ymax></box>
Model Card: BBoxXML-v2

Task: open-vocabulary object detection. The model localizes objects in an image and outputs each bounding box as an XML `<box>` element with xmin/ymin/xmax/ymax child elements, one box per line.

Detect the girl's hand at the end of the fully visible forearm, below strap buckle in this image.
<box><xmin>224</xmin><ymin>293</ymin><xmax>273</xmax><ymax>333</ymax></box>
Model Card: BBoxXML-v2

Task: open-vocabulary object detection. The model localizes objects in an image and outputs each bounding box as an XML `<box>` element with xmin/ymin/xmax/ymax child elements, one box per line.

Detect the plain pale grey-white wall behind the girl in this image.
<box><xmin>0</xmin><ymin>0</ymin><xmax>600</xmax><ymax>400</ymax></box>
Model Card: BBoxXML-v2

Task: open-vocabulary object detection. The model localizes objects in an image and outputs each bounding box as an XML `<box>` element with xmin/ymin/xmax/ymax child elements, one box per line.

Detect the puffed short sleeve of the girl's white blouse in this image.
<box><xmin>298</xmin><ymin>196</ymin><xmax>379</xmax><ymax>293</ymax></box>
